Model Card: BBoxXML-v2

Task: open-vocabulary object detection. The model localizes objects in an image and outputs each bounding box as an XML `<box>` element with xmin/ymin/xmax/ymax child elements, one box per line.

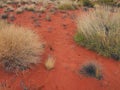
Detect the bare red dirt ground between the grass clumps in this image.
<box><xmin>0</xmin><ymin>7</ymin><xmax>120</xmax><ymax>90</ymax></box>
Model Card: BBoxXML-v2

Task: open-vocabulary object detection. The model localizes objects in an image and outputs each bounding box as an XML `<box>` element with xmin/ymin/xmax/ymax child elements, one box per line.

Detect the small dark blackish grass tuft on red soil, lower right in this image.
<box><xmin>80</xmin><ymin>62</ymin><xmax>102</xmax><ymax>80</ymax></box>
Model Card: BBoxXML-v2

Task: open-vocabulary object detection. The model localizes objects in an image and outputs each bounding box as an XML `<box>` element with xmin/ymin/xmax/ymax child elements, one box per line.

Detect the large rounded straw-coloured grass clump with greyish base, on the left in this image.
<box><xmin>0</xmin><ymin>20</ymin><xmax>43</xmax><ymax>71</ymax></box>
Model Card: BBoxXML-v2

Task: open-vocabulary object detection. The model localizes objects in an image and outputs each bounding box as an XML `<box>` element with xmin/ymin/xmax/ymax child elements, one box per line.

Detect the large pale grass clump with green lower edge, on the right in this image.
<box><xmin>74</xmin><ymin>7</ymin><xmax>120</xmax><ymax>60</ymax></box>
